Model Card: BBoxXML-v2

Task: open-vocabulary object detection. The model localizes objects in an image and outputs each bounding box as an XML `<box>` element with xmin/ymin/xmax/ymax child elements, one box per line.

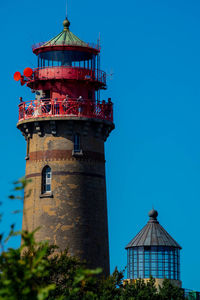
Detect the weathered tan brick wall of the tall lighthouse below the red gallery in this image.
<box><xmin>18</xmin><ymin>120</ymin><xmax>111</xmax><ymax>275</ymax></box>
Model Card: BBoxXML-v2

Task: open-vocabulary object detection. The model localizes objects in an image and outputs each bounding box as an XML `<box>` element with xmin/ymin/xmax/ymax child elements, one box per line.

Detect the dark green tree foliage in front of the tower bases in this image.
<box><xmin>0</xmin><ymin>179</ymin><xmax>184</xmax><ymax>300</ymax></box>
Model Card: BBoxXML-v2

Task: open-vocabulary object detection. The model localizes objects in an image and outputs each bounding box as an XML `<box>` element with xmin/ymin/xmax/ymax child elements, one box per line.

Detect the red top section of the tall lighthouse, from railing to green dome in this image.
<box><xmin>17</xmin><ymin>18</ymin><xmax>113</xmax><ymax>121</ymax></box>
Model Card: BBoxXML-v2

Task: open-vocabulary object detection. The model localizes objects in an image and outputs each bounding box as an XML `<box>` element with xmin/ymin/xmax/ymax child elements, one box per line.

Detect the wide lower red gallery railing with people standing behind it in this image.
<box><xmin>19</xmin><ymin>98</ymin><xmax>113</xmax><ymax>122</ymax></box>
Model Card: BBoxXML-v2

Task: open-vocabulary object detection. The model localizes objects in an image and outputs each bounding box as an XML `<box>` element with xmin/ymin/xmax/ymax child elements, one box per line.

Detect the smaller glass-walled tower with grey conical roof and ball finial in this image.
<box><xmin>126</xmin><ymin>209</ymin><xmax>181</xmax><ymax>287</ymax></box>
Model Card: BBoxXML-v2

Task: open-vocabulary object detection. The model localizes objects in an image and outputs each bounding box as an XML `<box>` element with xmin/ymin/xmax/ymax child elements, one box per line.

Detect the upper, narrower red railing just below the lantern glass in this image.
<box><xmin>33</xmin><ymin>66</ymin><xmax>106</xmax><ymax>85</ymax></box>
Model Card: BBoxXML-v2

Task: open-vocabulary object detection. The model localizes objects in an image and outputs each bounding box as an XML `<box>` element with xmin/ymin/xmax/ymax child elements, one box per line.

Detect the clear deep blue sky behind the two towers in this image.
<box><xmin>0</xmin><ymin>0</ymin><xmax>200</xmax><ymax>290</ymax></box>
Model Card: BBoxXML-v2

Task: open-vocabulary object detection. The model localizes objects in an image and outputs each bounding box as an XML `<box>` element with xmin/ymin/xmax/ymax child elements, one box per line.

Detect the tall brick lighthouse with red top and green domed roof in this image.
<box><xmin>15</xmin><ymin>18</ymin><xmax>114</xmax><ymax>275</ymax></box>
